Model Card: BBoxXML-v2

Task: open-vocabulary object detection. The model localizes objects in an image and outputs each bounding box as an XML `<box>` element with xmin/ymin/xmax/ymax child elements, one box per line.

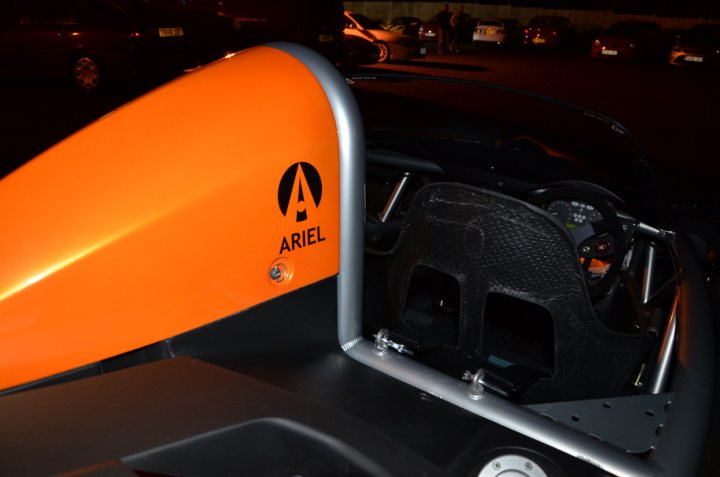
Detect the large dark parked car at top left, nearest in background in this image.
<box><xmin>0</xmin><ymin>0</ymin><xmax>232</xmax><ymax>92</ymax></box>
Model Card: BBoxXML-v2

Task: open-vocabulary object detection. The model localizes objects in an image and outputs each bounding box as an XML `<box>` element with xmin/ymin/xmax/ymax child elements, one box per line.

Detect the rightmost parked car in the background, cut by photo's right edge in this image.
<box><xmin>668</xmin><ymin>23</ymin><xmax>720</xmax><ymax>68</ymax></box>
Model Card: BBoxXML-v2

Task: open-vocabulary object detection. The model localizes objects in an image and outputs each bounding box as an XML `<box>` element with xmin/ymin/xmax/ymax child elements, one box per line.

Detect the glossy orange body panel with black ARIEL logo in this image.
<box><xmin>0</xmin><ymin>47</ymin><xmax>339</xmax><ymax>389</ymax></box>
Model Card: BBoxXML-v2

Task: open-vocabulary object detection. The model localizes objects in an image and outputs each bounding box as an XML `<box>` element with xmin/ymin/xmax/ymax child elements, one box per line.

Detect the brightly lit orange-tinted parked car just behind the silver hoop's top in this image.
<box><xmin>345</xmin><ymin>11</ymin><xmax>427</xmax><ymax>63</ymax></box>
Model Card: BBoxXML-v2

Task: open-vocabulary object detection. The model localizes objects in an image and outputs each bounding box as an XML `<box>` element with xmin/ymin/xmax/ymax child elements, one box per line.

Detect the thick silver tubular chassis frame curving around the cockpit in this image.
<box><xmin>270</xmin><ymin>43</ymin><xmax>714</xmax><ymax>476</ymax></box>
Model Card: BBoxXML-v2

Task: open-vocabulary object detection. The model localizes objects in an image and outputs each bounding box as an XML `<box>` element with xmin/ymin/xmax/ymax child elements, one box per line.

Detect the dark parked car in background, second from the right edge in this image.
<box><xmin>590</xmin><ymin>20</ymin><xmax>662</xmax><ymax>61</ymax></box>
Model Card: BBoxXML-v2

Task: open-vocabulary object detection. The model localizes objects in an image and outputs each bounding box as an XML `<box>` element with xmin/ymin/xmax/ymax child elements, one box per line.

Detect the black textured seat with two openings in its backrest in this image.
<box><xmin>387</xmin><ymin>183</ymin><xmax>647</xmax><ymax>402</ymax></box>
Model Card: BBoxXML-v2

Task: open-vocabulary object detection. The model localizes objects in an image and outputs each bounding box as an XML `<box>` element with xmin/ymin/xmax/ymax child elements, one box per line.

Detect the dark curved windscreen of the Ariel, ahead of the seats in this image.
<box><xmin>349</xmin><ymin>74</ymin><xmax>646</xmax><ymax>199</ymax></box>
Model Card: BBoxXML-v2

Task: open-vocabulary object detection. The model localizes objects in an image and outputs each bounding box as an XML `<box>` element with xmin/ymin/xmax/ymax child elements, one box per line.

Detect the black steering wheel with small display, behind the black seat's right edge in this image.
<box><xmin>530</xmin><ymin>187</ymin><xmax>626</xmax><ymax>300</ymax></box>
